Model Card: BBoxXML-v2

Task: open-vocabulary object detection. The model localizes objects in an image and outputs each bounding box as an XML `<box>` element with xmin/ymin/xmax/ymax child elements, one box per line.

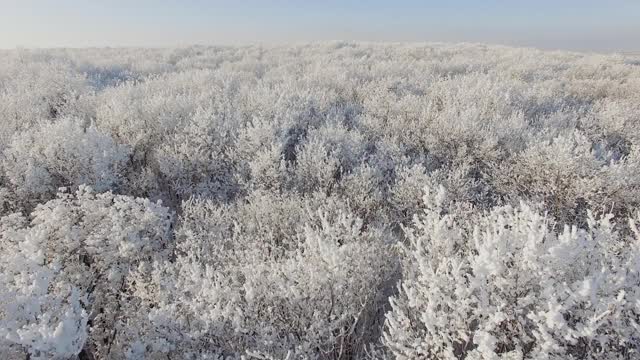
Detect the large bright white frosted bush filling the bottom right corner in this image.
<box><xmin>385</xmin><ymin>189</ymin><xmax>640</xmax><ymax>359</ymax></box>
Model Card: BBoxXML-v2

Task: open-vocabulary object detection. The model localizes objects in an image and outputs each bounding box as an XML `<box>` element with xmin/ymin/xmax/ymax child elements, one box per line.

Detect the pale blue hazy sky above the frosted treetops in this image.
<box><xmin>0</xmin><ymin>0</ymin><xmax>640</xmax><ymax>52</ymax></box>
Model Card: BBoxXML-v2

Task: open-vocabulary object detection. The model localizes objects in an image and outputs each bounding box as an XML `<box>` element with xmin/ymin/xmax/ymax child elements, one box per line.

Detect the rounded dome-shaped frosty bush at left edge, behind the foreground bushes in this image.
<box><xmin>2</xmin><ymin>119</ymin><xmax>130</xmax><ymax>207</ymax></box>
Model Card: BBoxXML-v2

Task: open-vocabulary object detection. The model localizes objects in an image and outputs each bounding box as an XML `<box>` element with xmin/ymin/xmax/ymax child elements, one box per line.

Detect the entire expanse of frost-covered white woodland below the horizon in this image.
<box><xmin>0</xmin><ymin>42</ymin><xmax>640</xmax><ymax>360</ymax></box>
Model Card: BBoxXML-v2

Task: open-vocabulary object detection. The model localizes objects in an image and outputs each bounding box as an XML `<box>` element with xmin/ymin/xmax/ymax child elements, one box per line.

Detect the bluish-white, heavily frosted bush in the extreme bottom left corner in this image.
<box><xmin>0</xmin><ymin>215</ymin><xmax>89</xmax><ymax>359</ymax></box>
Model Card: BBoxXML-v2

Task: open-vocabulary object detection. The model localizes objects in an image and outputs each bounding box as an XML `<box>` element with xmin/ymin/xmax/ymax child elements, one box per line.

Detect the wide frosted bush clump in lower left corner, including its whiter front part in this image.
<box><xmin>0</xmin><ymin>186</ymin><xmax>171</xmax><ymax>359</ymax></box>
